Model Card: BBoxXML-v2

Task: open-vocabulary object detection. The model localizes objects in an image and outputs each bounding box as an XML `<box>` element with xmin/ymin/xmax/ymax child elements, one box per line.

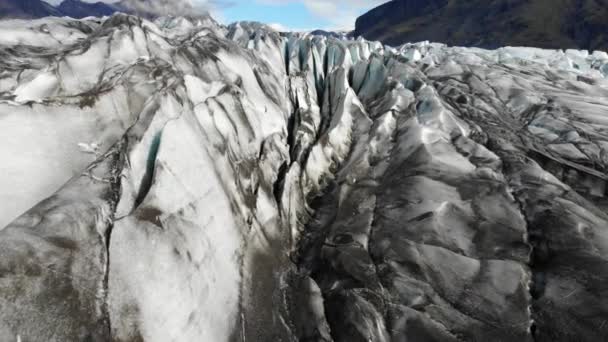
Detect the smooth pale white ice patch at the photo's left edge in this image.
<box><xmin>0</xmin><ymin>104</ymin><xmax>134</xmax><ymax>229</ymax></box>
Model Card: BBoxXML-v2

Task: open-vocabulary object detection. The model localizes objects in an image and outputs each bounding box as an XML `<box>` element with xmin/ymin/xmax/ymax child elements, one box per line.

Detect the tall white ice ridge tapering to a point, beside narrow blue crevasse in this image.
<box><xmin>110</xmin><ymin>115</ymin><xmax>242</xmax><ymax>342</ymax></box>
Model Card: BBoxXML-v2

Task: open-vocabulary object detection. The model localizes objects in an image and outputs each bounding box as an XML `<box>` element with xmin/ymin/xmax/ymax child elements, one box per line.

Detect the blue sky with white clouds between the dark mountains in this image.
<box><xmin>47</xmin><ymin>0</ymin><xmax>388</xmax><ymax>31</ymax></box>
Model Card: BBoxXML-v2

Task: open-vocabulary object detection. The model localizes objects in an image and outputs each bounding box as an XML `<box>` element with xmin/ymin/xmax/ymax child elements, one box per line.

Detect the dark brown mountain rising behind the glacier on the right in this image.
<box><xmin>355</xmin><ymin>0</ymin><xmax>608</xmax><ymax>51</ymax></box>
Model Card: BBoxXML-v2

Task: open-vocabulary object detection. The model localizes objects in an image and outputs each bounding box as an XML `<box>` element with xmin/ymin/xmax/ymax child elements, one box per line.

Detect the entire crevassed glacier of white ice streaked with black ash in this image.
<box><xmin>0</xmin><ymin>15</ymin><xmax>608</xmax><ymax>342</ymax></box>
